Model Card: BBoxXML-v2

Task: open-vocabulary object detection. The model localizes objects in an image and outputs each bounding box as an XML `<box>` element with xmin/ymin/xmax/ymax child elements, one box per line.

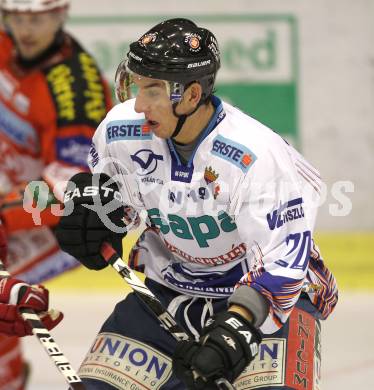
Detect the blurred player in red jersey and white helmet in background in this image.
<box><xmin>0</xmin><ymin>0</ymin><xmax>112</xmax><ymax>390</ymax></box>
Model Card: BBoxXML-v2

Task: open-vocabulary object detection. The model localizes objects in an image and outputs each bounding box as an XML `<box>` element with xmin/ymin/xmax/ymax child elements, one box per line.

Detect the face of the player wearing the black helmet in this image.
<box><xmin>133</xmin><ymin>74</ymin><xmax>178</xmax><ymax>138</ymax></box>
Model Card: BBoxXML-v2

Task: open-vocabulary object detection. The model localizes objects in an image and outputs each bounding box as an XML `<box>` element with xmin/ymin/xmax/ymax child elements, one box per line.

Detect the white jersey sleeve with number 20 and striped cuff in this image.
<box><xmin>235</xmin><ymin>146</ymin><xmax>316</xmax><ymax>333</ymax></box>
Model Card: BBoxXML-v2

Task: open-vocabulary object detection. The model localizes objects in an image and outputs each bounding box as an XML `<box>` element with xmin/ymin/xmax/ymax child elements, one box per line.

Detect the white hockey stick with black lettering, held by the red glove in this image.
<box><xmin>0</xmin><ymin>259</ymin><xmax>86</xmax><ymax>390</ymax></box>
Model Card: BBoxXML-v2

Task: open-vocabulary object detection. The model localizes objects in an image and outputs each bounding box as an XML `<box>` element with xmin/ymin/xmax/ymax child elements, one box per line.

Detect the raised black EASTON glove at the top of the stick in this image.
<box><xmin>55</xmin><ymin>172</ymin><xmax>126</xmax><ymax>270</ymax></box>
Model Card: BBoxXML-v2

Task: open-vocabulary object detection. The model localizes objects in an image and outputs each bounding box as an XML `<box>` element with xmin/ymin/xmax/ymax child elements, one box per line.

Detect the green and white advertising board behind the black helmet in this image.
<box><xmin>68</xmin><ymin>14</ymin><xmax>299</xmax><ymax>145</ymax></box>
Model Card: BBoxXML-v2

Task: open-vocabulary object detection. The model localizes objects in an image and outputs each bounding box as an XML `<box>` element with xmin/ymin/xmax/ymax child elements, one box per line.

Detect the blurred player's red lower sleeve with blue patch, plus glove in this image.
<box><xmin>0</xmin><ymin>123</ymin><xmax>95</xmax><ymax>234</ymax></box>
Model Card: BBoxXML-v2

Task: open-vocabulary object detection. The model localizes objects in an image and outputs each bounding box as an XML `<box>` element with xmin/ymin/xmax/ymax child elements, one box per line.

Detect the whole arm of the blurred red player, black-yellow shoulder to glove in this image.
<box><xmin>0</xmin><ymin>52</ymin><xmax>112</xmax><ymax>233</ymax></box>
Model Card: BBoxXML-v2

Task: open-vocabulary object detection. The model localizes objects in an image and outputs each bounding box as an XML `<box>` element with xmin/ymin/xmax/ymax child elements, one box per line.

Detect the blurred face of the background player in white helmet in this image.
<box><xmin>5</xmin><ymin>11</ymin><xmax>62</xmax><ymax>60</ymax></box>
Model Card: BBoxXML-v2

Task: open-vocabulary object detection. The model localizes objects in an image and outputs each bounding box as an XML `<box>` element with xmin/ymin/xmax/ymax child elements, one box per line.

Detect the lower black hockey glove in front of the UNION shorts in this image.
<box><xmin>173</xmin><ymin>312</ymin><xmax>262</xmax><ymax>390</ymax></box>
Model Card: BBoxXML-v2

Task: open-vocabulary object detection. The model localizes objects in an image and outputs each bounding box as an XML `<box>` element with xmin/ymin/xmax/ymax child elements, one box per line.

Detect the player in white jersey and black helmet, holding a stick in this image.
<box><xmin>57</xmin><ymin>19</ymin><xmax>337</xmax><ymax>390</ymax></box>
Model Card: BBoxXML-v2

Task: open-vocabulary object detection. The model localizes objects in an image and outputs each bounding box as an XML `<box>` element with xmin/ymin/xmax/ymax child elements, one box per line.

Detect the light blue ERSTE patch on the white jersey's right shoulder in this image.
<box><xmin>211</xmin><ymin>135</ymin><xmax>257</xmax><ymax>173</ymax></box>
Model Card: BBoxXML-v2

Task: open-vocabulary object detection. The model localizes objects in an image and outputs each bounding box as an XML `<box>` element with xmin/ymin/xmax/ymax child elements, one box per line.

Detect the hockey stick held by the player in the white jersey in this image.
<box><xmin>101</xmin><ymin>243</ymin><xmax>235</xmax><ymax>390</ymax></box>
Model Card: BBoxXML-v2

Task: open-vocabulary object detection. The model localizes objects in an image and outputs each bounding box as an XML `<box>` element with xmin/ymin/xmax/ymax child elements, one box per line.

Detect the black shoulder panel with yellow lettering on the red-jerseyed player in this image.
<box><xmin>43</xmin><ymin>34</ymin><xmax>108</xmax><ymax>128</ymax></box>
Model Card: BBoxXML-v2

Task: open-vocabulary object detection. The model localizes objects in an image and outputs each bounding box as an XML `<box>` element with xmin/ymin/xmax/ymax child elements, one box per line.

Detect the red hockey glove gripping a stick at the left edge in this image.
<box><xmin>0</xmin><ymin>278</ymin><xmax>63</xmax><ymax>337</ymax></box>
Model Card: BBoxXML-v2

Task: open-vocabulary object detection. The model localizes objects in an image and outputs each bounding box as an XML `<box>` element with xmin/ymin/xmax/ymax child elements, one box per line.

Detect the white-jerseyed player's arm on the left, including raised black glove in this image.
<box><xmin>56</xmin><ymin>105</ymin><xmax>148</xmax><ymax>270</ymax></box>
